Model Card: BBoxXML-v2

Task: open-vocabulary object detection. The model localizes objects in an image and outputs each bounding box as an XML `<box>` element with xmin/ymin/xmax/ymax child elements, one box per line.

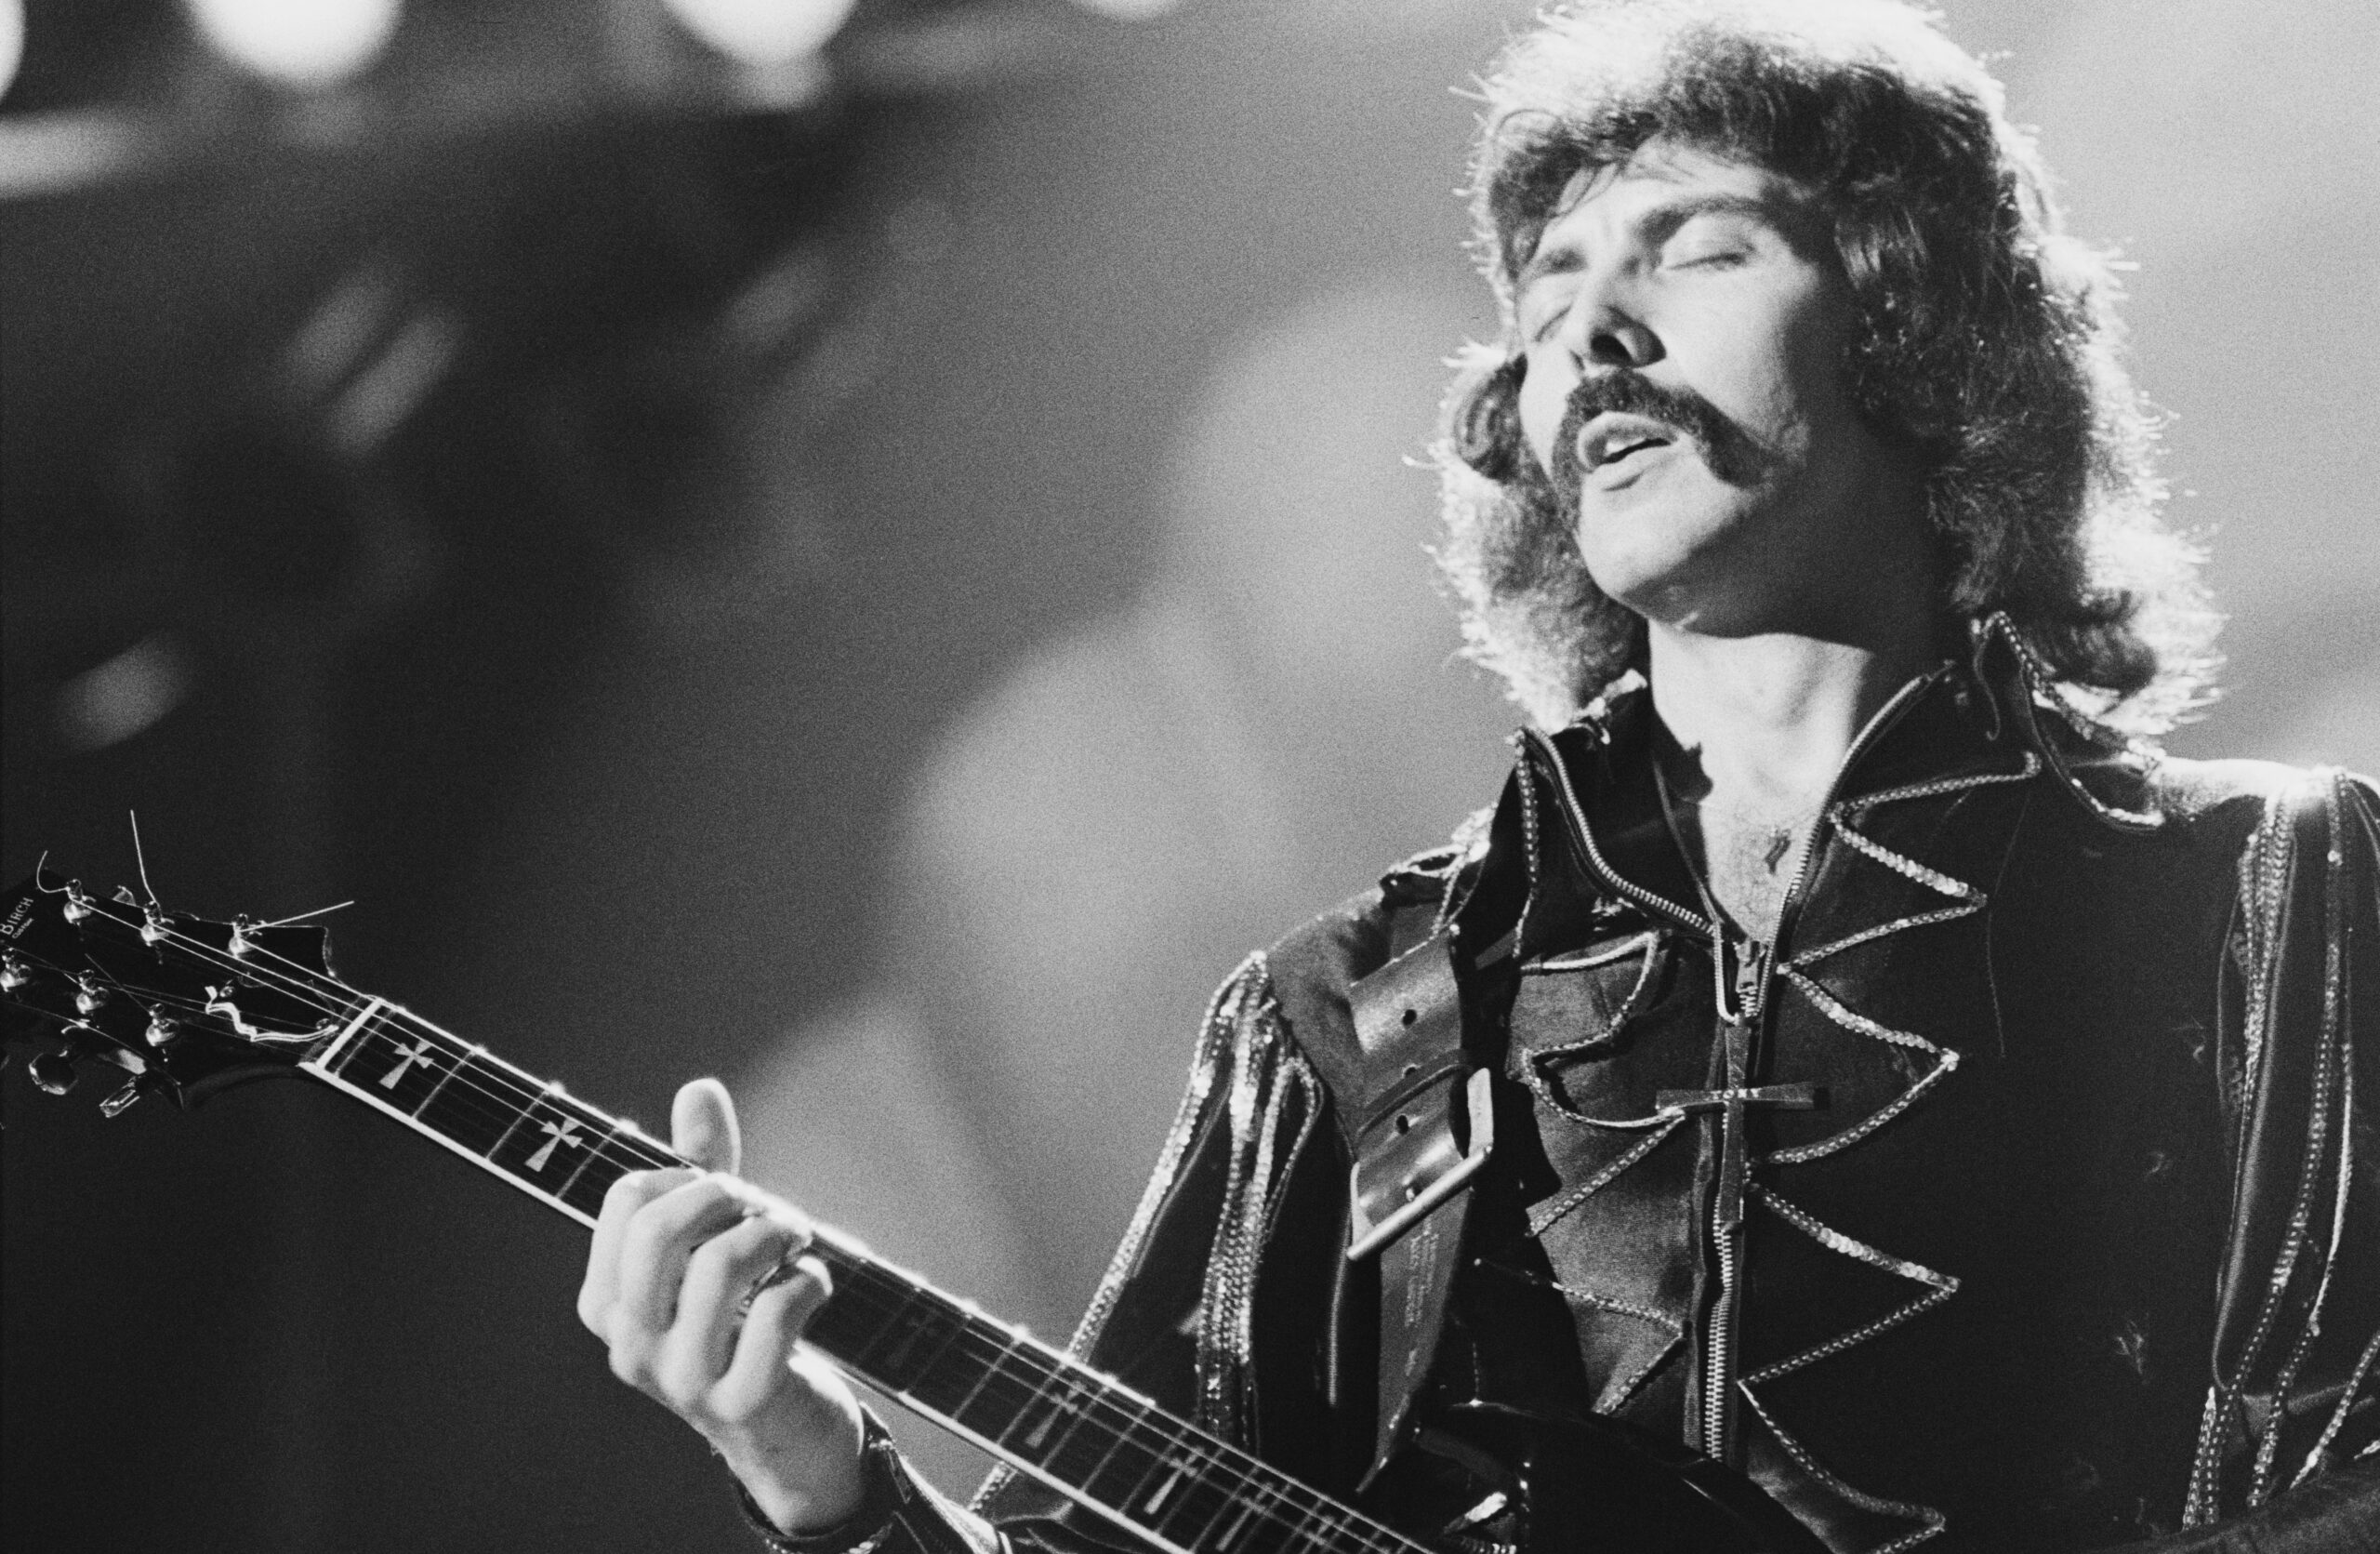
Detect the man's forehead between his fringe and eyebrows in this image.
<box><xmin>1518</xmin><ymin>140</ymin><xmax>1823</xmax><ymax>281</ymax></box>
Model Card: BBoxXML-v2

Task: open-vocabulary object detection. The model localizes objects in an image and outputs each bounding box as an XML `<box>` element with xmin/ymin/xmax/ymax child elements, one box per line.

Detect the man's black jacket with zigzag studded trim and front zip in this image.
<box><xmin>757</xmin><ymin>638</ymin><xmax>2380</xmax><ymax>1554</ymax></box>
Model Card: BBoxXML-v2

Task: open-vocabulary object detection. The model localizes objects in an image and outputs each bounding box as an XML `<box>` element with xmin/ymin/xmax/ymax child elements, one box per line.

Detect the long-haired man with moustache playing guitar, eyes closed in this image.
<box><xmin>581</xmin><ymin>0</ymin><xmax>2380</xmax><ymax>1554</ymax></box>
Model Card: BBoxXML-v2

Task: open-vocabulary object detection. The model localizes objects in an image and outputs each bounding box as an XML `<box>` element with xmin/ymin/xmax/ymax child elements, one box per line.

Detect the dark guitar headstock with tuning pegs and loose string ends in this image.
<box><xmin>0</xmin><ymin>869</ymin><xmax>357</xmax><ymax>1116</ymax></box>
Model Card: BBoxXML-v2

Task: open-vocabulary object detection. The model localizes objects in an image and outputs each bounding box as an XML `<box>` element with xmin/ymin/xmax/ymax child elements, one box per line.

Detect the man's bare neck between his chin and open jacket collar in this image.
<box><xmin>1647</xmin><ymin>621</ymin><xmax>1935</xmax><ymax>812</ymax></box>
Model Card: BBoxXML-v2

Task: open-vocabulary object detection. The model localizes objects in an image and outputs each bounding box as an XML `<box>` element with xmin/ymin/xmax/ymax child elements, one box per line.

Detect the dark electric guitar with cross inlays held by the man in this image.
<box><xmin>0</xmin><ymin>871</ymin><xmax>1820</xmax><ymax>1554</ymax></box>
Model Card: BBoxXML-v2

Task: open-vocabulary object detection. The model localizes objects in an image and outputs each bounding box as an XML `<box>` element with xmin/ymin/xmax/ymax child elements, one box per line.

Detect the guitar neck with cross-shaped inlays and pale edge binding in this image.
<box><xmin>300</xmin><ymin>997</ymin><xmax>1419</xmax><ymax>1554</ymax></box>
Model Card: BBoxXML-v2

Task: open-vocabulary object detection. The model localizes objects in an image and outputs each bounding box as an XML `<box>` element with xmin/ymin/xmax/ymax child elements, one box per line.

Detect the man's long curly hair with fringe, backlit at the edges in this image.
<box><xmin>1433</xmin><ymin>0</ymin><xmax>2218</xmax><ymax>737</ymax></box>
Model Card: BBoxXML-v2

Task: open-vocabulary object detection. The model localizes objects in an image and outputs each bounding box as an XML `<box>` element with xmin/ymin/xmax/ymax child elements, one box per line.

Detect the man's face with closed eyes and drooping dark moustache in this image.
<box><xmin>1518</xmin><ymin>143</ymin><xmax>1923</xmax><ymax>635</ymax></box>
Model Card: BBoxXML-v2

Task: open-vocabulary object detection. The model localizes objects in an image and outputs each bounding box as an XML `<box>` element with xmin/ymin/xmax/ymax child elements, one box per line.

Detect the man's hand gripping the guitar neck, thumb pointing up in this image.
<box><xmin>578</xmin><ymin>1078</ymin><xmax>864</xmax><ymax>1533</ymax></box>
